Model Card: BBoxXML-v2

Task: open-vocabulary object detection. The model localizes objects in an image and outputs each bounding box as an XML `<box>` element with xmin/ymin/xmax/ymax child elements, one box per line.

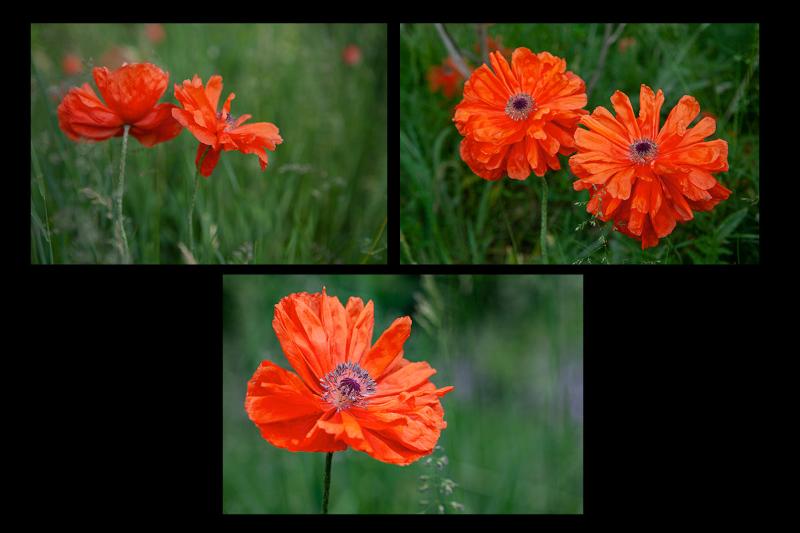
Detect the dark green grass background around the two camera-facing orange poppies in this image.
<box><xmin>400</xmin><ymin>24</ymin><xmax>759</xmax><ymax>264</ymax></box>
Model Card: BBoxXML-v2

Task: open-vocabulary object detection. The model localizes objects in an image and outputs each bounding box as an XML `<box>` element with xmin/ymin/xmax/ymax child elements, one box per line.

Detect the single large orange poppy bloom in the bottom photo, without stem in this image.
<box><xmin>244</xmin><ymin>289</ymin><xmax>453</xmax><ymax>465</ymax></box>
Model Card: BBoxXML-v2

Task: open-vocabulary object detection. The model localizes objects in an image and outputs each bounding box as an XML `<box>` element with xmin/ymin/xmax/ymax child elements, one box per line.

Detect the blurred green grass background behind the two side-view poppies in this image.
<box><xmin>31</xmin><ymin>24</ymin><xmax>387</xmax><ymax>264</ymax></box>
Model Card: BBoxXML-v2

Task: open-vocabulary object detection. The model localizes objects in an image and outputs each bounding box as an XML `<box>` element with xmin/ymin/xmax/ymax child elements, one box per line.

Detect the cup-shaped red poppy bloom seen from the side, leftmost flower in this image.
<box><xmin>57</xmin><ymin>63</ymin><xmax>181</xmax><ymax>147</ymax></box>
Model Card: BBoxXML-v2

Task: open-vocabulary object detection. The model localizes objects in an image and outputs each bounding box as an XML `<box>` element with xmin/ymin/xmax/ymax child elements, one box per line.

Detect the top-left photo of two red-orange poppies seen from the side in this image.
<box><xmin>30</xmin><ymin>23</ymin><xmax>388</xmax><ymax>264</ymax></box>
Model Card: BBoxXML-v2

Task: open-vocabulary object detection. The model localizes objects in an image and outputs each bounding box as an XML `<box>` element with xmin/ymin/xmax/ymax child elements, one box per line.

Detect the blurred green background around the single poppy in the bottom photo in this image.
<box><xmin>222</xmin><ymin>275</ymin><xmax>583</xmax><ymax>513</ymax></box>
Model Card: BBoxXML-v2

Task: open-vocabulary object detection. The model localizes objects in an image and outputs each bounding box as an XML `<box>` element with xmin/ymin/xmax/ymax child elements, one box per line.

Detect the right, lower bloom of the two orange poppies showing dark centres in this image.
<box><xmin>569</xmin><ymin>85</ymin><xmax>731</xmax><ymax>249</ymax></box>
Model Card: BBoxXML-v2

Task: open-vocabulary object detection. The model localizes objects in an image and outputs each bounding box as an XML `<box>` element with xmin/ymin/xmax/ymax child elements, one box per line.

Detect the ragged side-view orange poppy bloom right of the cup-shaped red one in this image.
<box><xmin>172</xmin><ymin>75</ymin><xmax>283</xmax><ymax>177</ymax></box>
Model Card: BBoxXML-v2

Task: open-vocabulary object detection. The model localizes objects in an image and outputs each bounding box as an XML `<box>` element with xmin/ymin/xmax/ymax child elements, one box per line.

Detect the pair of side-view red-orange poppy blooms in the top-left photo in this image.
<box><xmin>57</xmin><ymin>63</ymin><xmax>283</xmax><ymax>177</ymax></box>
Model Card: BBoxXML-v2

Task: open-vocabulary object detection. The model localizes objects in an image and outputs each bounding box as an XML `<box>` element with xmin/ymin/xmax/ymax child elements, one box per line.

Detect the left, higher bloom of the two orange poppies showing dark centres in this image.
<box><xmin>453</xmin><ymin>48</ymin><xmax>586</xmax><ymax>180</ymax></box>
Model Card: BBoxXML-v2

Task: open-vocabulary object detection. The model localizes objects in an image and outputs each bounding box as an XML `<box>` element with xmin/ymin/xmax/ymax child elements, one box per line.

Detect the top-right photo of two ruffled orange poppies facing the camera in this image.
<box><xmin>400</xmin><ymin>23</ymin><xmax>760</xmax><ymax>264</ymax></box>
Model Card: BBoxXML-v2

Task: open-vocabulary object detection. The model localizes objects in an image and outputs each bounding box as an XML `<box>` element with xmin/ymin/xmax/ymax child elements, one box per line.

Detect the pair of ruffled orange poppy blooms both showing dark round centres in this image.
<box><xmin>453</xmin><ymin>48</ymin><xmax>731</xmax><ymax>249</ymax></box>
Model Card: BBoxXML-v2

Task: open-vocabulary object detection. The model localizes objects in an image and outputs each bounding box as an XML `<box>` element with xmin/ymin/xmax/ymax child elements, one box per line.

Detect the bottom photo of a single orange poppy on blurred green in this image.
<box><xmin>221</xmin><ymin>274</ymin><xmax>583</xmax><ymax>514</ymax></box>
